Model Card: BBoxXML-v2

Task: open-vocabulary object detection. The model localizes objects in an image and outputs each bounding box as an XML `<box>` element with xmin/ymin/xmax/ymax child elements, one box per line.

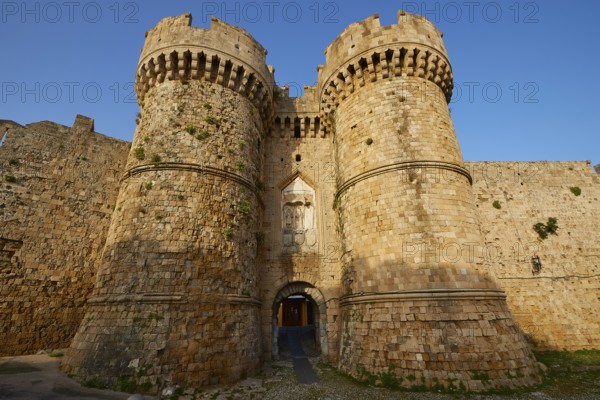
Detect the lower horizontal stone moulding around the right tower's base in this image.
<box><xmin>340</xmin><ymin>289</ymin><xmax>506</xmax><ymax>307</ymax></box>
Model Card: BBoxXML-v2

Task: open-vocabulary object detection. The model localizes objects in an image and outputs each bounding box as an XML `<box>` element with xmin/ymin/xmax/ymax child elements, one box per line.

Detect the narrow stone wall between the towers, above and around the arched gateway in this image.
<box><xmin>259</xmin><ymin>87</ymin><xmax>341</xmax><ymax>362</ymax></box>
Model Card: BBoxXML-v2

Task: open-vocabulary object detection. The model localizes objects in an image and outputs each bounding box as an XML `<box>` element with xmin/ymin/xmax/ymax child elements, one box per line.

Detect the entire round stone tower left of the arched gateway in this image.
<box><xmin>63</xmin><ymin>14</ymin><xmax>274</xmax><ymax>389</ymax></box>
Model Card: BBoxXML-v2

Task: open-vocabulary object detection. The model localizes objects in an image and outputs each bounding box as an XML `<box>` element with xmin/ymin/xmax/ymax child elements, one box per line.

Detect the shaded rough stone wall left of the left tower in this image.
<box><xmin>0</xmin><ymin>116</ymin><xmax>128</xmax><ymax>355</ymax></box>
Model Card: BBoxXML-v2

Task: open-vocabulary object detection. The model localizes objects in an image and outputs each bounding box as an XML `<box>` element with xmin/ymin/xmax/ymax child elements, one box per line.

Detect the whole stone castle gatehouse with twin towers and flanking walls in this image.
<box><xmin>0</xmin><ymin>7</ymin><xmax>600</xmax><ymax>392</ymax></box>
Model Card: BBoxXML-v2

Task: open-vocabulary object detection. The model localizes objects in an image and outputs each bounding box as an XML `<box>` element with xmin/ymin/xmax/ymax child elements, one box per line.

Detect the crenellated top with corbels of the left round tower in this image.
<box><xmin>135</xmin><ymin>13</ymin><xmax>275</xmax><ymax>122</ymax></box>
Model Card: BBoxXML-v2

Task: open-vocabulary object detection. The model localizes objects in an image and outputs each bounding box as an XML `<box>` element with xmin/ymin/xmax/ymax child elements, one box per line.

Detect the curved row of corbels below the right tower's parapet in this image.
<box><xmin>320</xmin><ymin>42</ymin><xmax>454</xmax><ymax>133</ymax></box>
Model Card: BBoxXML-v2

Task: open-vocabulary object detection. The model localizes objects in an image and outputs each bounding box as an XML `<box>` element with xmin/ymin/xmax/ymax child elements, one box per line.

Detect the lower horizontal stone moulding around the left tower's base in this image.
<box><xmin>88</xmin><ymin>293</ymin><xmax>261</xmax><ymax>307</ymax></box>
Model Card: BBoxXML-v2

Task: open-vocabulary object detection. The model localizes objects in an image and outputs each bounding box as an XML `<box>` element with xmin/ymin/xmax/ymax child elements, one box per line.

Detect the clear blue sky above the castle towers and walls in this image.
<box><xmin>0</xmin><ymin>0</ymin><xmax>600</xmax><ymax>164</ymax></box>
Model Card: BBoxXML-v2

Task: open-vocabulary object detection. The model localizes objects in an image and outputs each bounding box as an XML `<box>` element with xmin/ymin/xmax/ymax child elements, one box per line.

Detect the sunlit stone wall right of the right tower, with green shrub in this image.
<box><xmin>472</xmin><ymin>161</ymin><xmax>600</xmax><ymax>350</ymax></box>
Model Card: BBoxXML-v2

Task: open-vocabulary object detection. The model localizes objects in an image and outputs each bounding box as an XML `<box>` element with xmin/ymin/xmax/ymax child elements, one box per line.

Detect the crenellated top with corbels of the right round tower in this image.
<box><xmin>318</xmin><ymin>11</ymin><xmax>453</xmax><ymax>131</ymax></box>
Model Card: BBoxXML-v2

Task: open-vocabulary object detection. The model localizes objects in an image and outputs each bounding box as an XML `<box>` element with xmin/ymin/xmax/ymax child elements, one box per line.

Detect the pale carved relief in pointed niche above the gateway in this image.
<box><xmin>281</xmin><ymin>176</ymin><xmax>318</xmax><ymax>254</ymax></box>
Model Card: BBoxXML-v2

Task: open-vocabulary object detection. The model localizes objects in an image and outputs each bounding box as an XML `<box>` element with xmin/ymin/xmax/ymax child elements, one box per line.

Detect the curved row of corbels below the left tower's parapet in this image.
<box><xmin>135</xmin><ymin>46</ymin><xmax>275</xmax><ymax>130</ymax></box>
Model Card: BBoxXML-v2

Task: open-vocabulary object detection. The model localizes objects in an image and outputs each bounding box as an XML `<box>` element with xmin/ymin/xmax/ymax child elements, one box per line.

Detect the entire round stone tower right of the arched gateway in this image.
<box><xmin>319</xmin><ymin>12</ymin><xmax>539</xmax><ymax>391</ymax></box>
